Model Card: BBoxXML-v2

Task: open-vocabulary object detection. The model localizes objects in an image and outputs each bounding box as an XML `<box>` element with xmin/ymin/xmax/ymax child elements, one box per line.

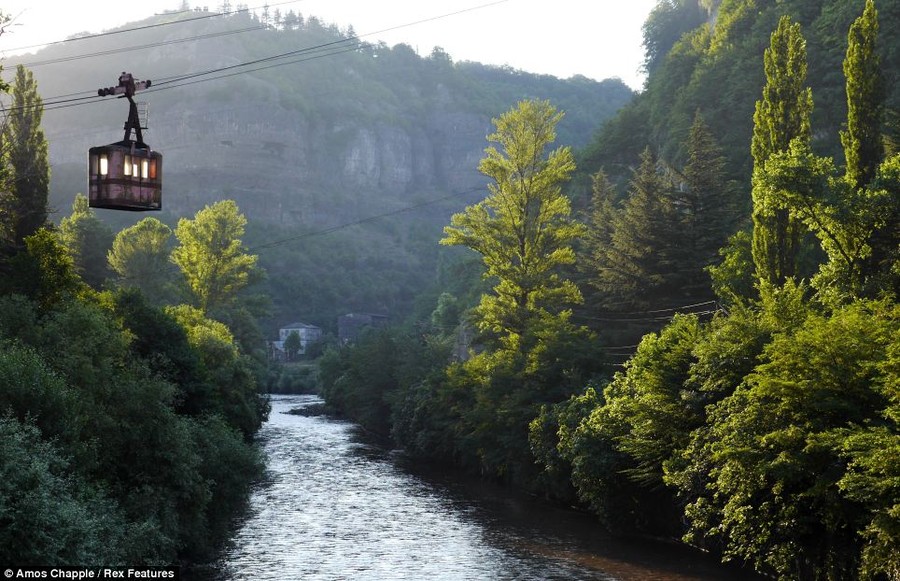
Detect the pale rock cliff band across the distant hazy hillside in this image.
<box><xmin>110</xmin><ymin>105</ymin><xmax>491</xmax><ymax>225</ymax></box>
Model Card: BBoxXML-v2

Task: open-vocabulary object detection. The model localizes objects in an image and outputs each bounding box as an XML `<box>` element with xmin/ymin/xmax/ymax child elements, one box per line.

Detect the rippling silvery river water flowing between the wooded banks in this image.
<box><xmin>203</xmin><ymin>396</ymin><xmax>753</xmax><ymax>581</ymax></box>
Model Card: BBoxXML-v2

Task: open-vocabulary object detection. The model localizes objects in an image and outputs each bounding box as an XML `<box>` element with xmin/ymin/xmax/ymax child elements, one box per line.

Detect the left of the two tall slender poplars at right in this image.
<box><xmin>751</xmin><ymin>16</ymin><xmax>813</xmax><ymax>284</ymax></box>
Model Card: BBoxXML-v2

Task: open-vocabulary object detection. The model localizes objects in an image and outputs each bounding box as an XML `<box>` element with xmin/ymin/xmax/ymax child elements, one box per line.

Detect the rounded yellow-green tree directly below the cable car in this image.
<box><xmin>107</xmin><ymin>218</ymin><xmax>172</xmax><ymax>303</ymax></box>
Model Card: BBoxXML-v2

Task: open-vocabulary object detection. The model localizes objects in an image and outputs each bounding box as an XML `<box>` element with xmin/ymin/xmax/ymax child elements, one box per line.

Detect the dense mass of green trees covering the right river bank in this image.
<box><xmin>321</xmin><ymin>0</ymin><xmax>900</xmax><ymax>579</ymax></box>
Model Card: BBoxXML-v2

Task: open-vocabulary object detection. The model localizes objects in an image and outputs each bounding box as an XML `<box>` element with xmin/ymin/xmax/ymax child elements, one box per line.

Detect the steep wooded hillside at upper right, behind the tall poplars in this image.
<box><xmin>581</xmin><ymin>0</ymin><xmax>900</xmax><ymax>191</ymax></box>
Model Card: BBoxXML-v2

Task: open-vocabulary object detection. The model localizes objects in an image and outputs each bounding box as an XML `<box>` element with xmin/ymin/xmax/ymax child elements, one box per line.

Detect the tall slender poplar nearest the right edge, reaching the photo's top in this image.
<box><xmin>841</xmin><ymin>0</ymin><xmax>885</xmax><ymax>188</ymax></box>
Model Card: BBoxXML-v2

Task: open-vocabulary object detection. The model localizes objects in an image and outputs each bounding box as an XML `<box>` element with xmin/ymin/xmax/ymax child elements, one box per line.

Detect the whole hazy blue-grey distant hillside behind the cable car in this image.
<box><xmin>4</xmin><ymin>6</ymin><xmax>633</xmax><ymax>330</ymax></box>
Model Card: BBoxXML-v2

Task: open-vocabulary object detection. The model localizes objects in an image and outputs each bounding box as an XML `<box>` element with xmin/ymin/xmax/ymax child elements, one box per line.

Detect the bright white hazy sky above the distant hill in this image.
<box><xmin>0</xmin><ymin>0</ymin><xmax>657</xmax><ymax>89</ymax></box>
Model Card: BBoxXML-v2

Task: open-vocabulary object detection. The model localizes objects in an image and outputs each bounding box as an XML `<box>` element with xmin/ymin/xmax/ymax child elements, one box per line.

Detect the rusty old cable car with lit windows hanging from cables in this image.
<box><xmin>88</xmin><ymin>73</ymin><xmax>162</xmax><ymax>211</ymax></box>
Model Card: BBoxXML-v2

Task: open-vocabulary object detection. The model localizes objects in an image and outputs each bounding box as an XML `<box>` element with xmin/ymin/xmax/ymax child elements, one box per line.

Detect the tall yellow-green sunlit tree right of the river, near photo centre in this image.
<box><xmin>441</xmin><ymin>101</ymin><xmax>581</xmax><ymax>338</ymax></box>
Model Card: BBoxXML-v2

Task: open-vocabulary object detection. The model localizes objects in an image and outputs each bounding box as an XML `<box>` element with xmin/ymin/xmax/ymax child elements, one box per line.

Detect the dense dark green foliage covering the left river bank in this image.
<box><xmin>0</xmin><ymin>68</ymin><xmax>268</xmax><ymax>566</ymax></box>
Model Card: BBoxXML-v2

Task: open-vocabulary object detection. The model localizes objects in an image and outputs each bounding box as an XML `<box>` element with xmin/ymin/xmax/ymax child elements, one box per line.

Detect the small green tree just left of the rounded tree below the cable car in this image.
<box><xmin>59</xmin><ymin>194</ymin><xmax>113</xmax><ymax>289</ymax></box>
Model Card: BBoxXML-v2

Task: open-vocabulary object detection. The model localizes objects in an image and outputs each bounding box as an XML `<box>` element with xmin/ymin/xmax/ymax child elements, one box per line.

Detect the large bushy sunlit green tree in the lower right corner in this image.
<box><xmin>686</xmin><ymin>302</ymin><xmax>897</xmax><ymax>579</ymax></box>
